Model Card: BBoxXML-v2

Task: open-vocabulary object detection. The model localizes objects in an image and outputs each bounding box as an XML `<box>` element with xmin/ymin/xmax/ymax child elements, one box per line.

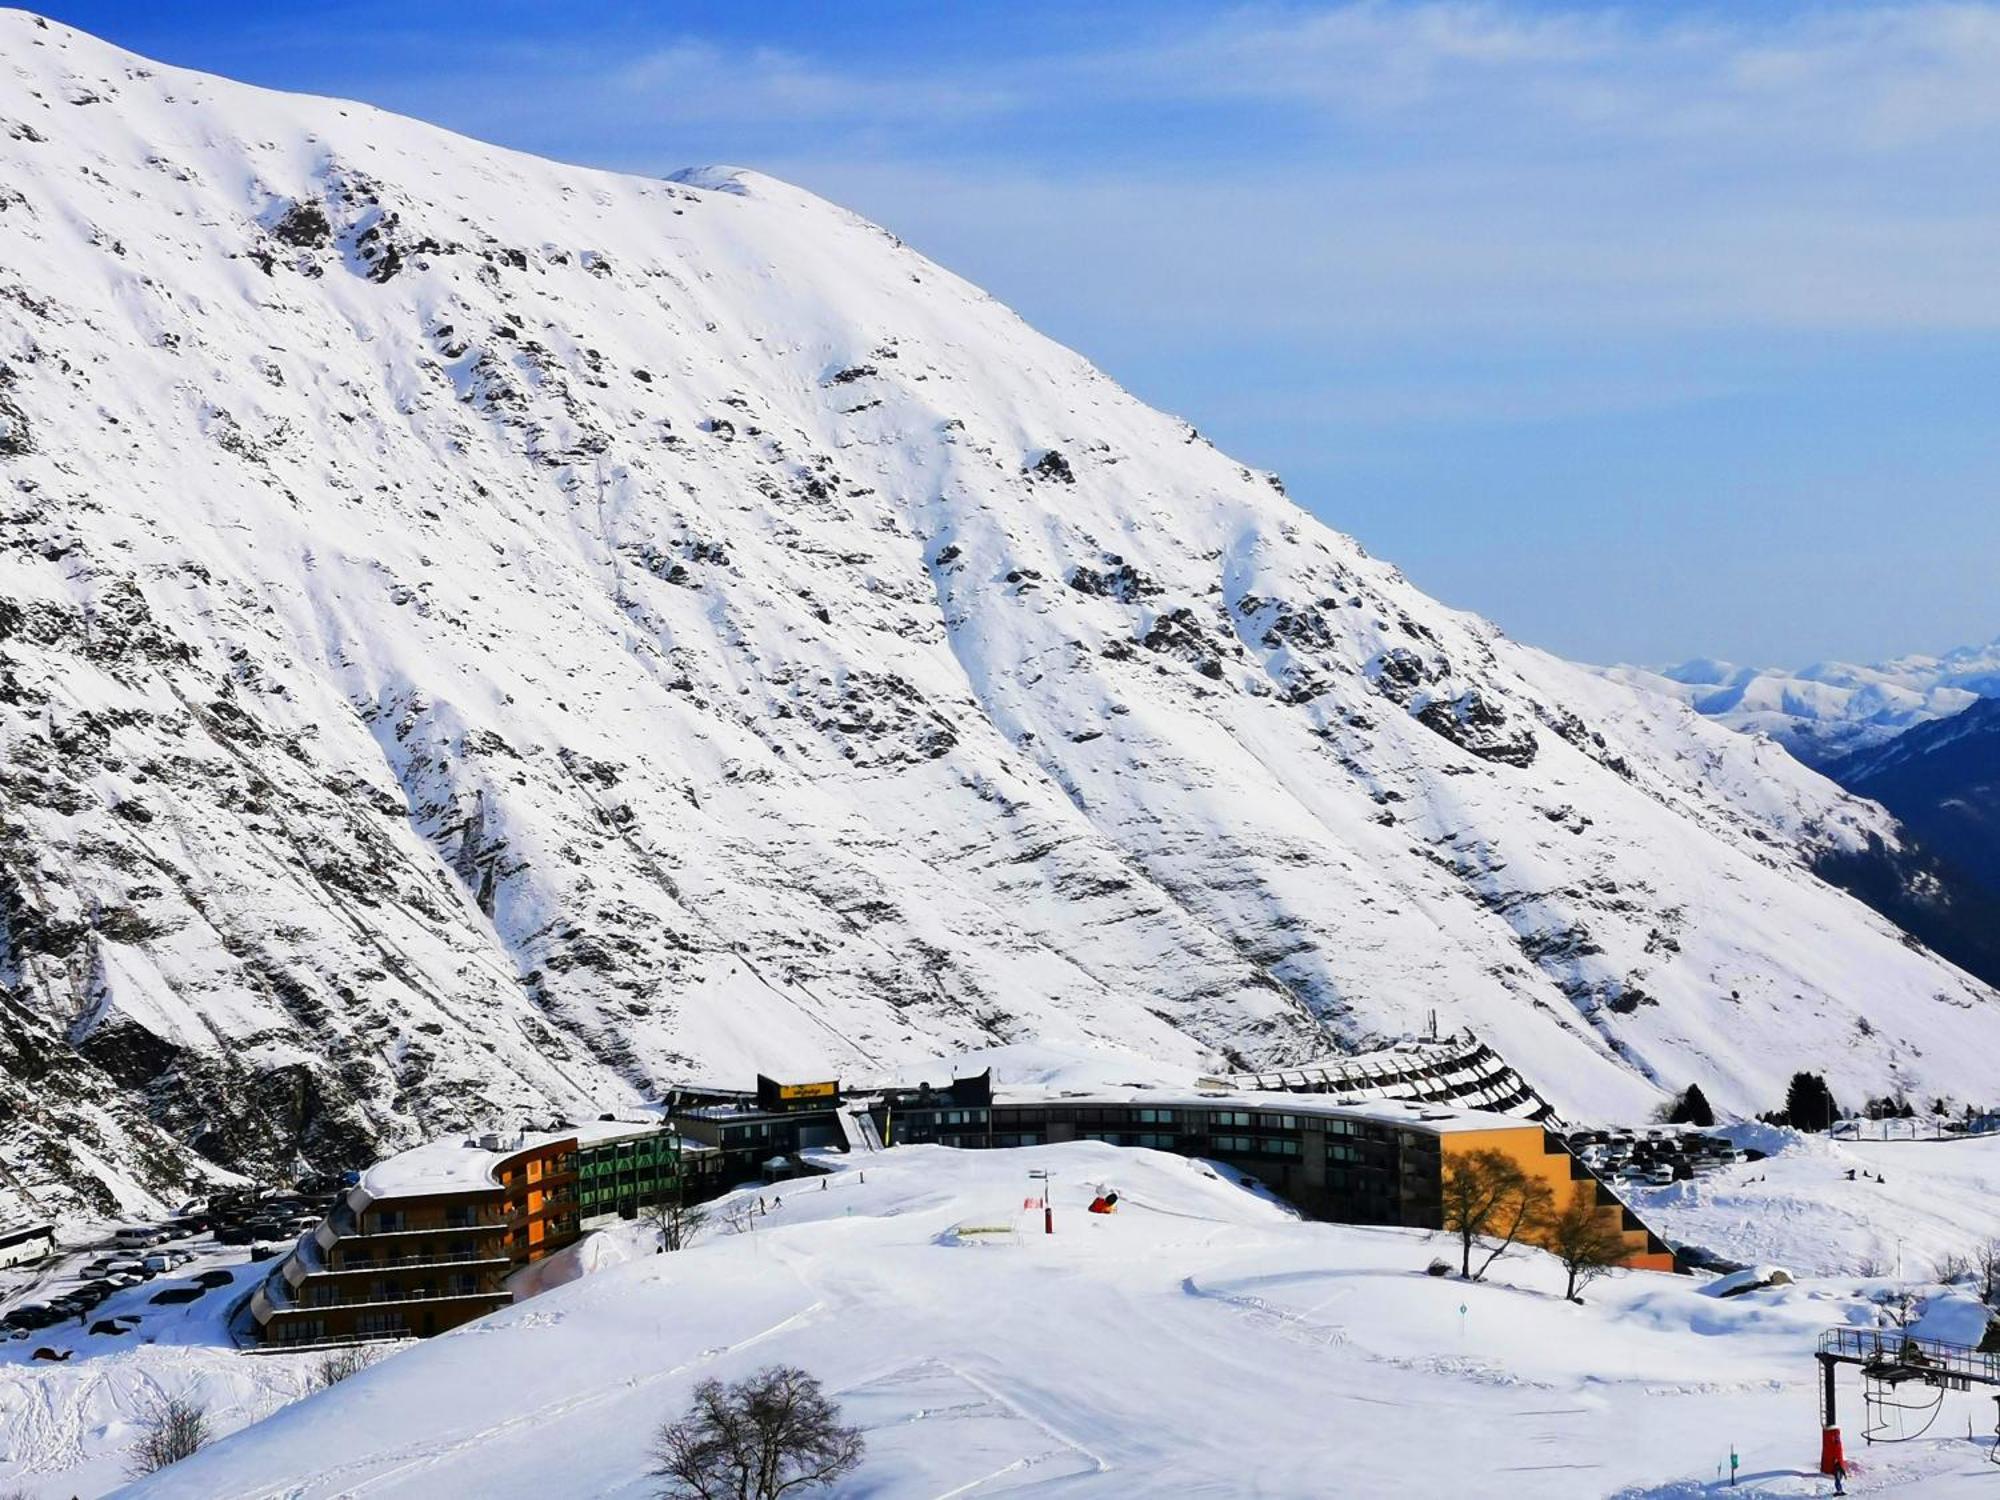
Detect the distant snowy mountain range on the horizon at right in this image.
<box><xmin>1606</xmin><ymin>636</ymin><xmax>2000</xmax><ymax>766</ymax></box>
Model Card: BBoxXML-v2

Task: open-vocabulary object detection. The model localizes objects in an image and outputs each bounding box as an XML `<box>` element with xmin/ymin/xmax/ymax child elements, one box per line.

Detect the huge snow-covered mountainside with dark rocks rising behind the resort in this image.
<box><xmin>0</xmin><ymin>12</ymin><xmax>2000</xmax><ymax>1224</ymax></box>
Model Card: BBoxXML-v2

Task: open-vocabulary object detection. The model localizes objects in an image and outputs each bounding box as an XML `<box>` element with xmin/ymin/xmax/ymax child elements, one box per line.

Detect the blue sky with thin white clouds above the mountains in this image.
<box><xmin>35</xmin><ymin>0</ymin><xmax>2000</xmax><ymax>664</ymax></box>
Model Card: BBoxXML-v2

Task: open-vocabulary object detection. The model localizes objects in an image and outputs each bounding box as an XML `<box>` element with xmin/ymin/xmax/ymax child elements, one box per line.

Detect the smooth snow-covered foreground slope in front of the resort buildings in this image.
<box><xmin>0</xmin><ymin>1144</ymin><xmax>1996</xmax><ymax>1500</ymax></box>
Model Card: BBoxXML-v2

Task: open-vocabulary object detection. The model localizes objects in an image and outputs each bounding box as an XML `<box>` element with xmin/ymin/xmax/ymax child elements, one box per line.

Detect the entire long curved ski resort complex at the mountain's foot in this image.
<box><xmin>266</xmin><ymin>1038</ymin><xmax>1674</xmax><ymax>1344</ymax></box>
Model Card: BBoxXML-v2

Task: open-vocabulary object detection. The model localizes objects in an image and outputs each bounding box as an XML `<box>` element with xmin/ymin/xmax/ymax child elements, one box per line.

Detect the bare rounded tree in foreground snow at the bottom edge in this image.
<box><xmin>652</xmin><ymin>1364</ymin><xmax>864</xmax><ymax>1500</ymax></box>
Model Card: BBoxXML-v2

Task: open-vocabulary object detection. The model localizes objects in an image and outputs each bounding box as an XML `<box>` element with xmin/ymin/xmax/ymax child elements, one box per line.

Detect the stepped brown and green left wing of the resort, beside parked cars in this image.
<box><xmin>250</xmin><ymin>1120</ymin><xmax>722</xmax><ymax>1344</ymax></box>
